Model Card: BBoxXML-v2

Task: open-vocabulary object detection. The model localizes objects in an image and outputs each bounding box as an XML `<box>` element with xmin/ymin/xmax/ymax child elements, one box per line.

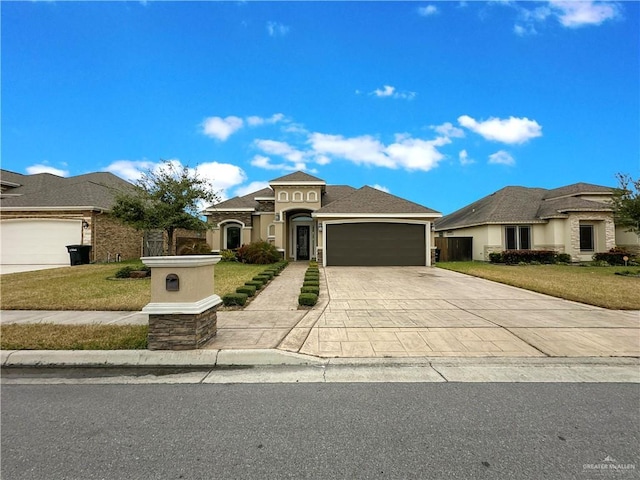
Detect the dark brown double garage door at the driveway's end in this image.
<box><xmin>326</xmin><ymin>222</ymin><xmax>426</xmax><ymax>266</ymax></box>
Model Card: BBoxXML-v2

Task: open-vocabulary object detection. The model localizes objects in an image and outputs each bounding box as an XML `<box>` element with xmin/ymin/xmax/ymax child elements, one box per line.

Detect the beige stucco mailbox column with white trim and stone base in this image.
<box><xmin>141</xmin><ymin>255</ymin><xmax>222</xmax><ymax>350</ymax></box>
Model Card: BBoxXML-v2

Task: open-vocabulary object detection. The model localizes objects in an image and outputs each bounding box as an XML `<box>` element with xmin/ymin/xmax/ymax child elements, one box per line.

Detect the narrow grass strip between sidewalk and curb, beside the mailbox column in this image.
<box><xmin>0</xmin><ymin>324</ymin><xmax>149</xmax><ymax>350</ymax></box>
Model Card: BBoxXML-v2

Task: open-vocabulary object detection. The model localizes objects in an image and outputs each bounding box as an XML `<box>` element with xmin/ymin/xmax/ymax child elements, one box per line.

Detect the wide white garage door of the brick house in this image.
<box><xmin>0</xmin><ymin>220</ymin><xmax>82</xmax><ymax>273</ymax></box>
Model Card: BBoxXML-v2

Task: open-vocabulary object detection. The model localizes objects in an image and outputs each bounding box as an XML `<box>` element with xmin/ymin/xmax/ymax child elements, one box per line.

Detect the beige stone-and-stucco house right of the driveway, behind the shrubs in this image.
<box><xmin>434</xmin><ymin>183</ymin><xmax>640</xmax><ymax>262</ymax></box>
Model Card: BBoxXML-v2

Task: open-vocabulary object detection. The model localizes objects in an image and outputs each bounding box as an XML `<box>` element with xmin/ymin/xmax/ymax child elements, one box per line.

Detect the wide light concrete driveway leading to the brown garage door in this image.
<box><xmin>279</xmin><ymin>267</ymin><xmax>640</xmax><ymax>357</ymax></box>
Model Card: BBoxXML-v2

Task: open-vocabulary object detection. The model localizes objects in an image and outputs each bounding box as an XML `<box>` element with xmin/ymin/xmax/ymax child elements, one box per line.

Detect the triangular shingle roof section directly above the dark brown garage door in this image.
<box><xmin>314</xmin><ymin>186</ymin><xmax>439</xmax><ymax>215</ymax></box>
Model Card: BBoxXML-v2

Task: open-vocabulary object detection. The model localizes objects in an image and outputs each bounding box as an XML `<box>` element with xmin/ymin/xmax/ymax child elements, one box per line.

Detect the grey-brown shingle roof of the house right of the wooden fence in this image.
<box><xmin>435</xmin><ymin>183</ymin><xmax>612</xmax><ymax>231</ymax></box>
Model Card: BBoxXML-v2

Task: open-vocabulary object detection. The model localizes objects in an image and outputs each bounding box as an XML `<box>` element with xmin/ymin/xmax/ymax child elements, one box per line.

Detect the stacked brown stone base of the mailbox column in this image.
<box><xmin>147</xmin><ymin>305</ymin><xmax>218</xmax><ymax>350</ymax></box>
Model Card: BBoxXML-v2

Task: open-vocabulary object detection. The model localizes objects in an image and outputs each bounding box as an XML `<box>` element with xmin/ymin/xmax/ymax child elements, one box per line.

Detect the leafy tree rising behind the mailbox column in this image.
<box><xmin>111</xmin><ymin>161</ymin><xmax>219</xmax><ymax>255</ymax></box>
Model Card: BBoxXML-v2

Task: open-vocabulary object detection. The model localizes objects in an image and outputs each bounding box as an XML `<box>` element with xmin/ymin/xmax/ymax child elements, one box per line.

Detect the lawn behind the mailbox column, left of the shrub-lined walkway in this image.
<box><xmin>0</xmin><ymin>262</ymin><xmax>276</xmax><ymax>311</ymax></box>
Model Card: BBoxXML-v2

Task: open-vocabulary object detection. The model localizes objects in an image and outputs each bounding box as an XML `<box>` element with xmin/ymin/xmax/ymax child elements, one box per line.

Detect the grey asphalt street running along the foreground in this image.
<box><xmin>1</xmin><ymin>383</ymin><xmax>640</xmax><ymax>480</ymax></box>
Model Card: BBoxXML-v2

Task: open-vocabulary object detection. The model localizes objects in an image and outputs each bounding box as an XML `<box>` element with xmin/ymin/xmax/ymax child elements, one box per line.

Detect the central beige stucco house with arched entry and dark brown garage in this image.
<box><xmin>205</xmin><ymin>172</ymin><xmax>441</xmax><ymax>266</ymax></box>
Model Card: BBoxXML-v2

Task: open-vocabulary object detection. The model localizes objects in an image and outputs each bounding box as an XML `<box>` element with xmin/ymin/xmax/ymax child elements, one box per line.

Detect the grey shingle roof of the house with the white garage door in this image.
<box><xmin>0</xmin><ymin>170</ymin><xmax>134</xmax><ymax>210</ymax></box>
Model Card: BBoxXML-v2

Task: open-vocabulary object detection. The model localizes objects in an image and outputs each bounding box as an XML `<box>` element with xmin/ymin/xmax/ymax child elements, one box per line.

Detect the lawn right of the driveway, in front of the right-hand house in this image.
<box><xmin>436</xmin><ymin>262</ymin><xmax>640</xmax><ymax>310</ymax></box>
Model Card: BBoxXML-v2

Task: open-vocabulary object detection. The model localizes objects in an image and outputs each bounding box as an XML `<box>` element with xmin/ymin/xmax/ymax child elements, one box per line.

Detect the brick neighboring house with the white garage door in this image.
<box><xmin>0</xmin><ymin>170</ymin><xmax>143</xmax><ymax>273</ymax></box>
